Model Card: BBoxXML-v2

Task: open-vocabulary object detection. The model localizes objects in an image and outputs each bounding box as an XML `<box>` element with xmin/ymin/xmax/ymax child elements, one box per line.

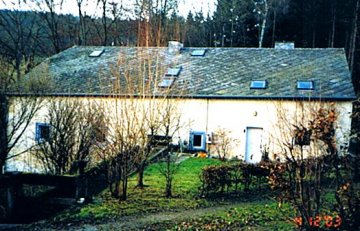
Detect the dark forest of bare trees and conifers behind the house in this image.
<box><xmin>0</xmin><ymin>0</ymin><xmax>360</xmax><ymax>92</ymax></box>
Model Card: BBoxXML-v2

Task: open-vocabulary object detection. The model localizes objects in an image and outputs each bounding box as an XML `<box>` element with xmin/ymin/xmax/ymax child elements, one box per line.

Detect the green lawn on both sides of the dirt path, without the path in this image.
<box><xmin>55</xmin><ymin>158</ymin><xmax>294</xmax><ymax>230</ymax></box>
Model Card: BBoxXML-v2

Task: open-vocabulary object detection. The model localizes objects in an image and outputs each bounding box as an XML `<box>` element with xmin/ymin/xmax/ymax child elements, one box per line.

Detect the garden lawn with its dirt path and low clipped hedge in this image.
<box><xmin>19</xmin><ymin>149</ymin><xmax>358</xmax><ymax>230</ymax></box>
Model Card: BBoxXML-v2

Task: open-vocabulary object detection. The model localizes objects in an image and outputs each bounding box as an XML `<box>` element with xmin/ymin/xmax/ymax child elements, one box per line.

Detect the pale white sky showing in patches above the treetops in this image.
<box><xmin>0</xmin><ymin>0</ymin><xmax>216</xmax><ymax>17</ymax></box>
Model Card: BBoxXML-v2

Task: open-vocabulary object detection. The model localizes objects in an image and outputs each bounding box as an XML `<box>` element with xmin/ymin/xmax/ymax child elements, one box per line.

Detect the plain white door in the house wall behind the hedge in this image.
<box><xmin>245</xmin><ymin>128</ymin><xmax>263</xmax><ymax>163</ymax></box>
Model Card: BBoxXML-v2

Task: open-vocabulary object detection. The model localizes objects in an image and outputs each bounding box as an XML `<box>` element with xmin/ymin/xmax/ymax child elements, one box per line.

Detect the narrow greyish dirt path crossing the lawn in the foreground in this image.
<box><xmin>44</xmin><ymin>202</ymin><xmax>244</xmax><ymax>231</ymax></box>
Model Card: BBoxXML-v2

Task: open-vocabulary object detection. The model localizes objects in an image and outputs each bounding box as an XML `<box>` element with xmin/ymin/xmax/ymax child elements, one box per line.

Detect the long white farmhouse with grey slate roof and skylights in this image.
<box><xmin>4</xmin><ymin>42</ymin><xmax>355</xmax><ymax>170</ymax></box>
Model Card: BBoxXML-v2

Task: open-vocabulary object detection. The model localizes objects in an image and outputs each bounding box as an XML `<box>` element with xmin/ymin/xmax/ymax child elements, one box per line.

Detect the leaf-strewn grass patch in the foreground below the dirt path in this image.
<box><xmin>147</xmin><ymin>201</ymin><xmax>295</xmax><ymax>230</ymax></box>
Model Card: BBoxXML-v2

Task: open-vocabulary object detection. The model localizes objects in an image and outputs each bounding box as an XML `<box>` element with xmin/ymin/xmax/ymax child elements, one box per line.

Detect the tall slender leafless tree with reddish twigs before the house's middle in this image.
<box><xmin>100</xmin><ymin>48</ymin><xmax>187</xmax><ymax>200</ymax></box>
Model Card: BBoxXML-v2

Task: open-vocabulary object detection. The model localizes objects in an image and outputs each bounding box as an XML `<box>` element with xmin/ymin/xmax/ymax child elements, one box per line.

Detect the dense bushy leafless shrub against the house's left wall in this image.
<box><xmin>33</xmin><ymin>98</ymin><xmax>106</xmax><ymax>175</ymax></box>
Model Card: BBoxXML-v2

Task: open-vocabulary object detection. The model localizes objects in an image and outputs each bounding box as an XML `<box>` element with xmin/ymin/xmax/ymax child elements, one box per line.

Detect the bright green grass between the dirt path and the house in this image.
<box><xmin>57</xmin><ymin>158</ymin><xmax>221</xmax><ymax>221</ymax></box>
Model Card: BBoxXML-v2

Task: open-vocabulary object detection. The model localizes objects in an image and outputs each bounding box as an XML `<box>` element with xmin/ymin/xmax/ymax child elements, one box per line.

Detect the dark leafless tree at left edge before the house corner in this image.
<box><xmin>0</xmin><ymin>60</ymin><xmax>50</xmax><ymax>174</ymax></box>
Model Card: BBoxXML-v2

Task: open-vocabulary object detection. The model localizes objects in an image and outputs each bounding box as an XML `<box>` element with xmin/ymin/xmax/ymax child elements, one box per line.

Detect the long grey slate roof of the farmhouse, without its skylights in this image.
<box><xmin>33</xmin><ymin>47</ymin><xmax>355</xmax><ymax>100</ymax></box>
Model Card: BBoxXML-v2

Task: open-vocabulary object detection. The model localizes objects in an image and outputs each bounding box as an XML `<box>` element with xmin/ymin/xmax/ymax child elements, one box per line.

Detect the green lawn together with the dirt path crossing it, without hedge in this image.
<box><xmin>27</xmin><ymin>157</ymin><xmax>296</xmax><ymax>230</ymax></box>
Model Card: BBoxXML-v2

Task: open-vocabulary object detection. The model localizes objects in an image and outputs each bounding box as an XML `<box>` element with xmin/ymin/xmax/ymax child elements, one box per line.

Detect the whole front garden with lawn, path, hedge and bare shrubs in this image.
<box><xmin>1</xmin><ymin>108</ymin><xmax>360</xmax><ymax>230</ymax></box>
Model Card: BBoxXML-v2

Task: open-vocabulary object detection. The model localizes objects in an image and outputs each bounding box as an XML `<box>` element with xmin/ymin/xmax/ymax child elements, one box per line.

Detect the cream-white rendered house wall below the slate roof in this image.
<box><xmin>8</xmin><ymin>98</ymin><xmax>352</xmax><ymax>171</ymax></box>
